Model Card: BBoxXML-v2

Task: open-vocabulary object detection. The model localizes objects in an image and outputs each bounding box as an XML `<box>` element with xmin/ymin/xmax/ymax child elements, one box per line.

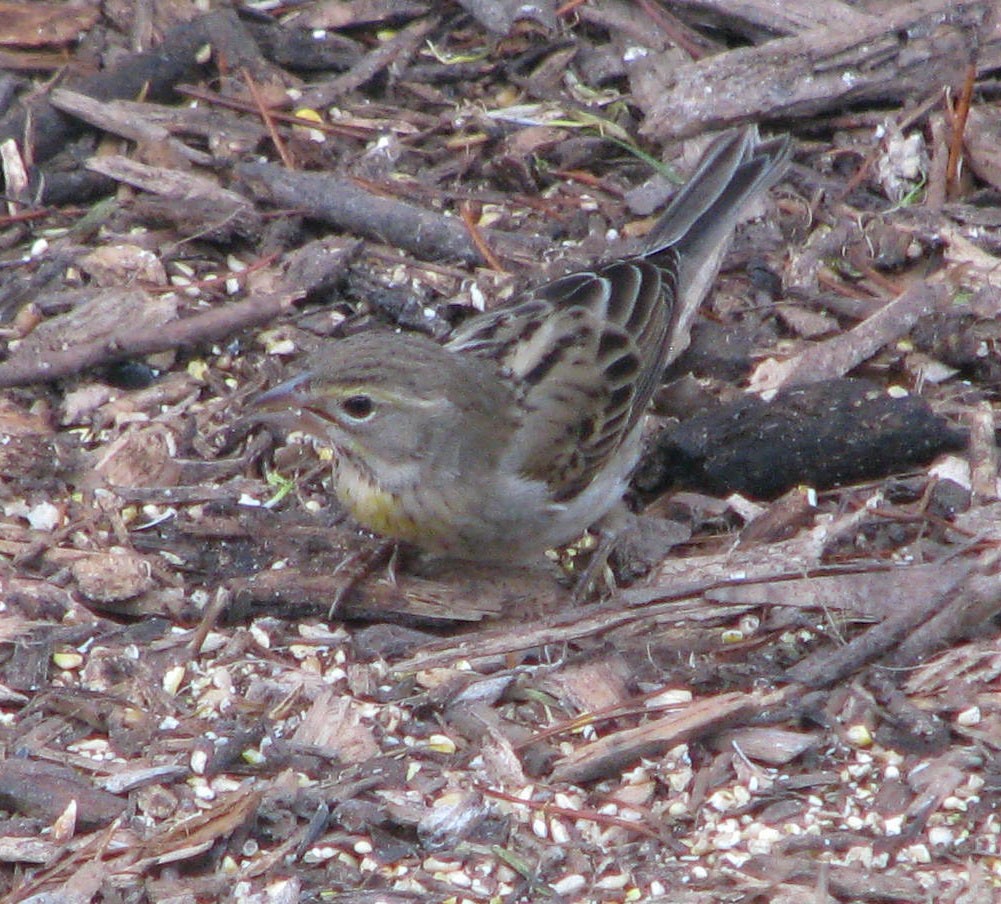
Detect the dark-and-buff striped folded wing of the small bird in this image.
<box><xmin>447</xmin><ymin>255</ymin><xmax>675</xmax><ymax>502</ymax></box>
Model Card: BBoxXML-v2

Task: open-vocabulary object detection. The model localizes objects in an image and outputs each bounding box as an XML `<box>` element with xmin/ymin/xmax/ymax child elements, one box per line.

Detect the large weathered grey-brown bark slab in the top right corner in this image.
<box><xmin>632</xmin><ymin>0</ymin><xmax>1001</xmax><ymax>141</ymax></box>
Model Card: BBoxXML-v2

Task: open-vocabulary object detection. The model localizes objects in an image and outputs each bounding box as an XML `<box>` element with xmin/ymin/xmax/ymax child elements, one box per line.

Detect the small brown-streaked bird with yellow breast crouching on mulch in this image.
<box><xmin>252</xmin><ymin>126</ymin><xmax>793</xmax><ymax>563</ymax></box>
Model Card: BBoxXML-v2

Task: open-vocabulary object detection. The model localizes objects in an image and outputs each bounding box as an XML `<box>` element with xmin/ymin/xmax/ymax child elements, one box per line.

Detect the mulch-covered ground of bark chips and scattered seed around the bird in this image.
<box><xmin>0</xmin><ymin>0</ymin><xmax>1001</xmax><ymax>904</ymax></box>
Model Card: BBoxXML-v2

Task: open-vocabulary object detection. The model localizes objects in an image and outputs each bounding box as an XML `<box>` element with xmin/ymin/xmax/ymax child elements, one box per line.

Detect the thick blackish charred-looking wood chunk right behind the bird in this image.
<box><xmin>633</xmin><ymin>380</ymin><xmax>966</xmax><ymax>500</ymax></box>
